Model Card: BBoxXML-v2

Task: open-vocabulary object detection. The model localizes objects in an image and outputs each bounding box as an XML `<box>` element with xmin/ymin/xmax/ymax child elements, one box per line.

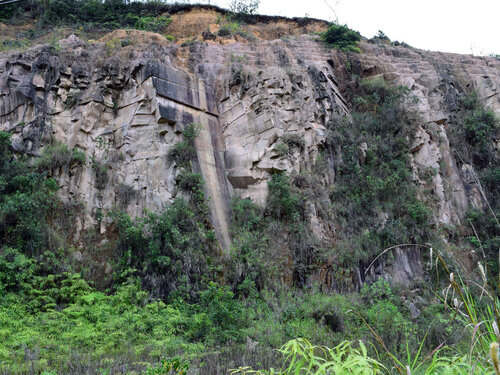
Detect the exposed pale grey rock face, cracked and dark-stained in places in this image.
<box><xmin>0</xmin><ymin>25</ymin><xmax>500</xmax><ymax>287</ymax></box>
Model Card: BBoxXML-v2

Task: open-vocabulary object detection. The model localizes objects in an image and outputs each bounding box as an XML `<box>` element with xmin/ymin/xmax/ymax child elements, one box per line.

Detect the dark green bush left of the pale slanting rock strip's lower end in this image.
<box><xmin>111</xmin><ymin>198</ymin><xmax>214</xmax><ymax>299</ymax></box>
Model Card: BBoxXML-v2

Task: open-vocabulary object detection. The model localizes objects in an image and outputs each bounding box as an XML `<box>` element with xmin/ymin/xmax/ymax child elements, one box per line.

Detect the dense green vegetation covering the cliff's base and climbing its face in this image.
<box><xmin>0</xmin><ymin>75</ymin><xmax>499</xmax><ymax>374</ymax></box>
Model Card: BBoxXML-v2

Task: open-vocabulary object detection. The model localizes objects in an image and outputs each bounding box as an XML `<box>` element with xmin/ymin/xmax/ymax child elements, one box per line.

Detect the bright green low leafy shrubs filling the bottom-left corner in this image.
<box><xmin>0</xmin><ymin>276</ymin><xmax>203</xmax><ymax>374</ymax></box>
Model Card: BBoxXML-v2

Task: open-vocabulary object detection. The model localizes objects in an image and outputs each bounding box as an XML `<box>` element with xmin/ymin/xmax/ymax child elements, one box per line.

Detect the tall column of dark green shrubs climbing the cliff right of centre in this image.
<box><xmin>327</xmin><ymin>80</ymin><xmax>432</xmax><ymax>265</ymax></box>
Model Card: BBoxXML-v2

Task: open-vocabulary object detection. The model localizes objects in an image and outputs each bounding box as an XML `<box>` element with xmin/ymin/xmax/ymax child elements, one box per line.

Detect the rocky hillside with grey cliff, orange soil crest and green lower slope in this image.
<box><xmin>0</xmin><ymin>5</ymin><xmax>500</xmax><ymax>374</ymax></box>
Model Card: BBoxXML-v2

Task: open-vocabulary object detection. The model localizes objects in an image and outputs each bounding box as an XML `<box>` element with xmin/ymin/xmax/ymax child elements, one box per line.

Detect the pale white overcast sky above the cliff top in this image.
<box><xmin>209</xmin><ymin>0</ymin><xmax>500</xmax><ymax>55</ymax></box>
